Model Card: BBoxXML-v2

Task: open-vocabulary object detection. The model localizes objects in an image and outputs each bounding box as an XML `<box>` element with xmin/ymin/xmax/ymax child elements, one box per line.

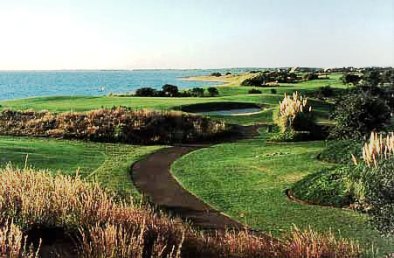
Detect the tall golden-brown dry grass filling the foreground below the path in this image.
<box><xmin>0</xmin><ymin>166</ymin><xmax>361</xmax><ymax>258</ymax></box>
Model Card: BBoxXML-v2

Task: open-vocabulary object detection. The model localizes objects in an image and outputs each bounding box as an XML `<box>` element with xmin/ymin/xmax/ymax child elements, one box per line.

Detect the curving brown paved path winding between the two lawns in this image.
<box><xmin>131</xmin><ymin>125</ymin><xmax>260</xmax><ymax>230</ymax></box>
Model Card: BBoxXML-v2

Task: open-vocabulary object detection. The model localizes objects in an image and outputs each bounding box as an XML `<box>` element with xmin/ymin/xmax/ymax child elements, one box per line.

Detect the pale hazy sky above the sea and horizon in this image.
<box><xmin>0</xmin><ymin>0</ymin><xmax>394</xmax><ymax>70</ymax></box>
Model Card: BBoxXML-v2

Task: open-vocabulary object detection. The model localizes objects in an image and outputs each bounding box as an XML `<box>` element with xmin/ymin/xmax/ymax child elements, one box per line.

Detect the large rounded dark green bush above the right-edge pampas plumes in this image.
<box><xmin>330</xmin><ymin>93</ymin><xmax>390</xmax><ymax>139</ymax></box>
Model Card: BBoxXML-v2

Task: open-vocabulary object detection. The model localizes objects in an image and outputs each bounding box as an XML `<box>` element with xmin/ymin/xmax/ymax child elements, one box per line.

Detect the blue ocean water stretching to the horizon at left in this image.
<box><xmin>0</xmin><ymin>70</ymin><xmax>226</xmax><ymax>100</ymax></box>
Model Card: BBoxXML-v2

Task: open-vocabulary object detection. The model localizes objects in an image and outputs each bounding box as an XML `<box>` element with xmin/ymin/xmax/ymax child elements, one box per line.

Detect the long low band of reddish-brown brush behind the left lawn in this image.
<box><xmin>0</xmin><ymin>108</ymin><xmax>226</xmax><ymax>144</ymax></box>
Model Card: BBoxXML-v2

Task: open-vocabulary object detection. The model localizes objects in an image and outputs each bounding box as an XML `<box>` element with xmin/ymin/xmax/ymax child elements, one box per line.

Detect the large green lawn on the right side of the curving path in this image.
<box><xmin>172</xmin><ymin>139</ymin><xmax>394</xmax><ymax>252</ymax></box>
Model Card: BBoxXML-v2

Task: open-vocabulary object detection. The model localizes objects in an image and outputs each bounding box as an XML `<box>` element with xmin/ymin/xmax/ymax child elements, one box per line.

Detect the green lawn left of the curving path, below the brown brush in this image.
<box><xmin>0</xmin><ymin>136</ymin><xmax>162</xmax><ymax>196</ymax></box>
